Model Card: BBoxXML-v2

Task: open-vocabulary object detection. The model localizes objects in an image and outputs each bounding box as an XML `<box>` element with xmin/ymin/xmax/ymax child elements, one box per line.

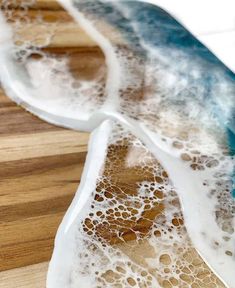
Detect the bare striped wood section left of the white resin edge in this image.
<box><xmin>0</xmin><ymin>91</ymin><xmax>89</xmax><ymax>288</ymax></box>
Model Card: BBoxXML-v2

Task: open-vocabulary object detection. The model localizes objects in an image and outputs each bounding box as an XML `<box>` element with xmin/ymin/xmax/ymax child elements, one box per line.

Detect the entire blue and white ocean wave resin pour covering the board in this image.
<box><xmin>0</xmin><ymin>0</ymin><xmax>235</xmax><ymax>288</ymax></box>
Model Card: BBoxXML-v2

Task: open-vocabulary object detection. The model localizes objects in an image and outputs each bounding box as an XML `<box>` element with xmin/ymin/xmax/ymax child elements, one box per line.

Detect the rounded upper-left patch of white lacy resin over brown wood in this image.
<box><xmin>0</xmin><ymin>0</ymin><xmax>107</xmax><ymax>125</ymax></box>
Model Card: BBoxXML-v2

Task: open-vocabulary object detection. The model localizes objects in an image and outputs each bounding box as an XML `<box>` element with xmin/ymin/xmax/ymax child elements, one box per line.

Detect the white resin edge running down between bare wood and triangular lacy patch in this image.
<box><xmin>47</xmin><ymin>120</ymin><xmax>112</xmax><ymax>288</ymax></box>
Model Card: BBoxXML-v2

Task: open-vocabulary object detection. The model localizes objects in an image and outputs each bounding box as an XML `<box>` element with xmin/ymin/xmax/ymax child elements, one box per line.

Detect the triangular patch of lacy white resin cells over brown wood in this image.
<box><xmin>60</xmin><ymin>125</ymin><xmax>224</xmax><ymax>288</ymax></box>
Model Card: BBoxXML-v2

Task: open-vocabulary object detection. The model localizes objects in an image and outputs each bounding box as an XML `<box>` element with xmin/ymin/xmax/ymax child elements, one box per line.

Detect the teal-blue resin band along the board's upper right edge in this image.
<box><xmin>74</xmin><ymin>0</ymin><xmax>235</xmax><ymax>197</ymax></box>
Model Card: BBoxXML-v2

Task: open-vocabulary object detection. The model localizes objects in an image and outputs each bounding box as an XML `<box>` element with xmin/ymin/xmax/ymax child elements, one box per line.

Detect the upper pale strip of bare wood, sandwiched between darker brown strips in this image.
<box><xmin>0</xmin><ymin>130</ymin><xmax>89</xmax><ymax>162</ymax></box>
